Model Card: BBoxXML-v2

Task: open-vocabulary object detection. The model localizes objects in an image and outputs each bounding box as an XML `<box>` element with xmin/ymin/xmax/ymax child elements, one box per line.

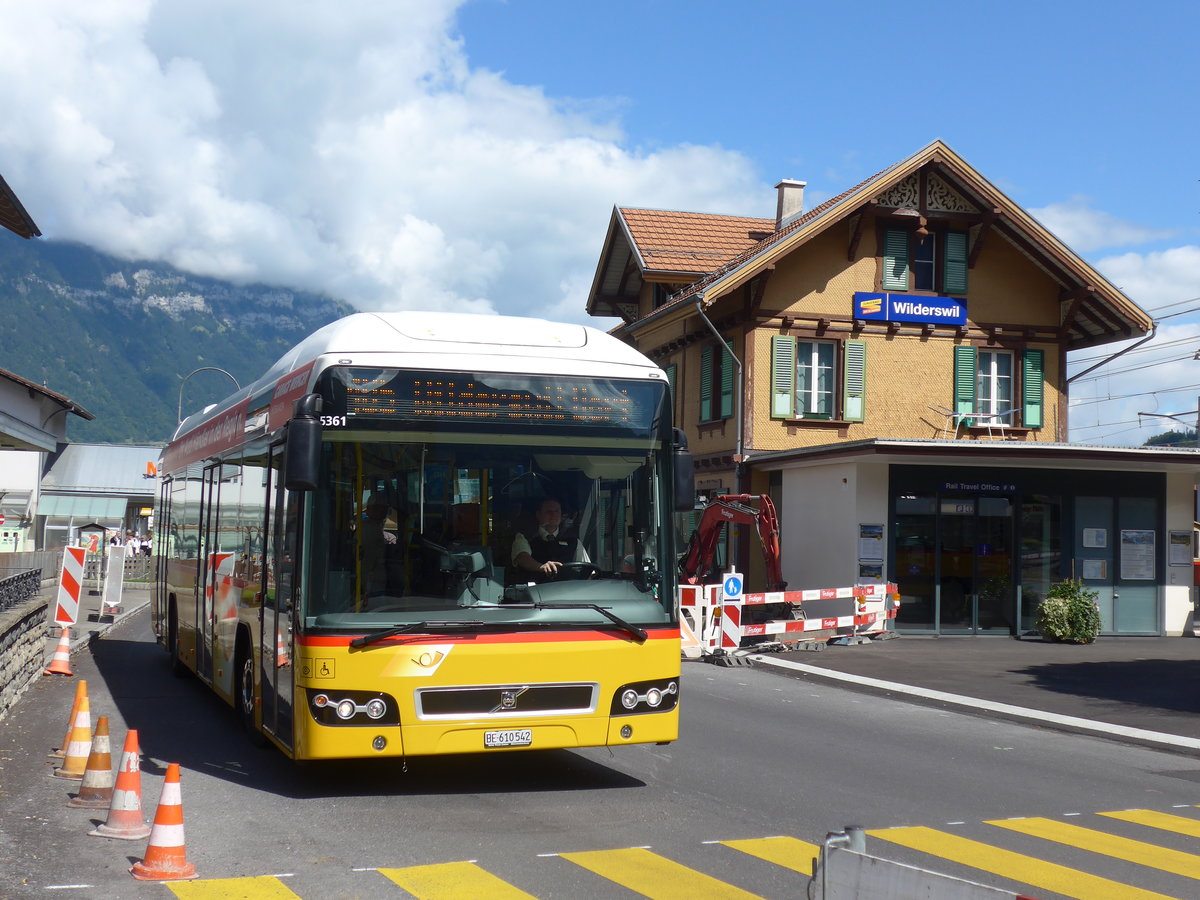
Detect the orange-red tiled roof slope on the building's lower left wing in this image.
<box><xmin>619</xmin><ymin>206</ymin><xmax>775</xmax><ymax>275</ymax></box>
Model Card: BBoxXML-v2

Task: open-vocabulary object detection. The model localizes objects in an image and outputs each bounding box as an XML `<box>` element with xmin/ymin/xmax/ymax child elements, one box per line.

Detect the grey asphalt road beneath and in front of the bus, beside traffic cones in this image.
<box><xmin>7</xmin><ymin>614</ymin><xmax>1200</xmax><ymax>900</ymax></box>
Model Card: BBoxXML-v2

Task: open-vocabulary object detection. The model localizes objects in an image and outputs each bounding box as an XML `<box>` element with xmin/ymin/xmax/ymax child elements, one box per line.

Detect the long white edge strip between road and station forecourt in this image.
<box><xmin>751</xmin><ymin>655</ymin><xmax>1200</xmax><ymax>751</ymax></box>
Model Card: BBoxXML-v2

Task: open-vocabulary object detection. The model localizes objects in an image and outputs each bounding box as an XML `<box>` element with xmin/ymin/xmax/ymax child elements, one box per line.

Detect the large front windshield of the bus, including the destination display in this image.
<box><xmin>300</xmin><ymin>367</ymin><xmax>674</xmax><ymax>640</ymax></box>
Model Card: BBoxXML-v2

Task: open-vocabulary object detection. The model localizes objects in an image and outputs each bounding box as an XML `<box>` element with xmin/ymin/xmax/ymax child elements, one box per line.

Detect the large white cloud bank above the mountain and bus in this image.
<box><xmin>0</xmin><ymin>0</ymin><xmax>773</xmax><ymax>320</ymax></box>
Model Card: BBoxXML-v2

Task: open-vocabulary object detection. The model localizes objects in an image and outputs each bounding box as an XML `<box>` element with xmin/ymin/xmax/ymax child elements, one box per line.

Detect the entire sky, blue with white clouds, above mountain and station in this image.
<box><xmin>0</xmin><ymin>0</ymin><xmax>1200</xmax><ymax>444</ymax></box>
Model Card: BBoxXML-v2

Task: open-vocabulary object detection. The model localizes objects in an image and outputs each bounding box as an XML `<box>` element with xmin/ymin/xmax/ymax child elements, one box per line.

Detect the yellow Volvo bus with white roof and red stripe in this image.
<box><xmin>152</xmin><ymin>312</ymin><xmax>692</xmax><ymax>760</ymax></box>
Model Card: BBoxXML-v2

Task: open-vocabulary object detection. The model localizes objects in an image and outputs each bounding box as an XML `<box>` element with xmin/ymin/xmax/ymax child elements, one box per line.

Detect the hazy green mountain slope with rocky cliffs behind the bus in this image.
<box><xmin>0</xmin><ymin>234</ymin><xmax>353</xmax><ymax>444</ymax></box>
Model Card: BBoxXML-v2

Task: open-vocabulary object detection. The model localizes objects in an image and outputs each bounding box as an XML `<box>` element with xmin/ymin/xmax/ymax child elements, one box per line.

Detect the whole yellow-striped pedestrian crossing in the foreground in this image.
<box><xmin>166</xmin><ymin>805</ymin><xmax>1200</xmax><ymax>900</ymax></box>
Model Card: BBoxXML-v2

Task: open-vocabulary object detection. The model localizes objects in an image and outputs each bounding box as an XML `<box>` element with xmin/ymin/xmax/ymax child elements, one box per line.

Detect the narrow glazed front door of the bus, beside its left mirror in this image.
<box><xmin>259</xmin><ymin>444</ymin><xmax>298</xmax><ymax>748</ymax></box>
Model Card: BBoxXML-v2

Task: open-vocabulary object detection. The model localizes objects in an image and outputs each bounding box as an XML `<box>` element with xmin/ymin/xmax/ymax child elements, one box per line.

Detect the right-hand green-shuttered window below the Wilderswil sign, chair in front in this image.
<box><xmin>954</xmin><ymin>347</ymin><xmax>1045</xmax><ymax>428</ymax></box>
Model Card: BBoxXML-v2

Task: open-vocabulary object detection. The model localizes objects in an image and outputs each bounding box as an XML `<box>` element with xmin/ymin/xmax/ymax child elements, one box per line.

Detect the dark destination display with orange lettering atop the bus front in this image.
<box><xmin>323</xmin><ymin>367</ymin><xmax>666</xmax><ymax>434</ymax></box>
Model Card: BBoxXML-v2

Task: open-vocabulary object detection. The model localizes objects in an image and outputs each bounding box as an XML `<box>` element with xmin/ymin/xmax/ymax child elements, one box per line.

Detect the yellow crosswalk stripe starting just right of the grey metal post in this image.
<box><xmin>868</xmin><ymin>826</ymin><xmax>1168</xmax><ymax>900</ymax></box>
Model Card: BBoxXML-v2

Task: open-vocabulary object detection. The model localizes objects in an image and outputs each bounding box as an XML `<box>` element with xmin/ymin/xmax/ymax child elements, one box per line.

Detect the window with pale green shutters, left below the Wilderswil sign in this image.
<box><xmin>770</xmin><ymin>335</ymin><xmax>866</xmax><ymax>422</ymax></box>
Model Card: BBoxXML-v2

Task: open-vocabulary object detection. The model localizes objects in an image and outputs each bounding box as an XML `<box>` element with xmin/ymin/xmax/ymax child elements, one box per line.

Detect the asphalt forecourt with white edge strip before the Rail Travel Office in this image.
<box><xmin>752</xmin><ymin>636</ymin><xmax>1200</xmax><ymax>751</ymax></box>
